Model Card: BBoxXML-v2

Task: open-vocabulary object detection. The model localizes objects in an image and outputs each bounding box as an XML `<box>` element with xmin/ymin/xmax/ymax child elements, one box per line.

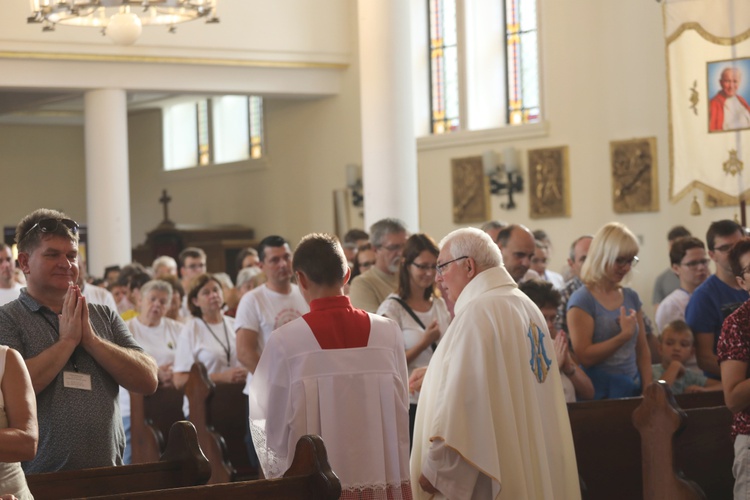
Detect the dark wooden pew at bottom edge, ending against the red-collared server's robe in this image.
<box><xmin>83</xmin><ymin>436</ymin><xmax>341</xmax><ymax>500</ymax></box>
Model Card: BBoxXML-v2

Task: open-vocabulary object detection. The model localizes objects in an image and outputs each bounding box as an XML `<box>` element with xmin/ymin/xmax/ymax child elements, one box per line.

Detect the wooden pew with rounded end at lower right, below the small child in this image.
<box><xmin>633</xmin><ymin>382</ymin><xmax>734</xmax><ymax>500</ymax></box>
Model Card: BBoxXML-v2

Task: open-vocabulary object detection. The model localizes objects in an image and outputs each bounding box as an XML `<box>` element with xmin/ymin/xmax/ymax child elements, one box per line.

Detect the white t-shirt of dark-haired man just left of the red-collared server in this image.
<box><xmin>234</xmin><ymin>284</ymin><xmax>310</xmax><ymax>394</ymax></box>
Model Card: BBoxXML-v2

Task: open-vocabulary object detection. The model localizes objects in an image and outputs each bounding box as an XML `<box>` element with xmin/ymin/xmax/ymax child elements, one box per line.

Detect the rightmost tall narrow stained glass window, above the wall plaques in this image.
<box><xmin>505</xmin><ymin>0</ymin><xmax>540</xmax><ymax>125</ymax></box>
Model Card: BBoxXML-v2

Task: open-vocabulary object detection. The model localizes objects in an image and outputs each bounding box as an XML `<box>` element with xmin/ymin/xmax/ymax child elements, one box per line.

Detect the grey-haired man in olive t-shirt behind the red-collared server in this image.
<box><xmin>349</xmin><ymin>218</ymin><xmax>407</xmax><ymax>313</ymax></box>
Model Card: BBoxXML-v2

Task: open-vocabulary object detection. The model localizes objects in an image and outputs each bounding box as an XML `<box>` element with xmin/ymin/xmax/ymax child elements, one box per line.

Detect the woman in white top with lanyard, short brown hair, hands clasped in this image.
<box><xmin>174</xmin><ymin>274</ymin><xmax>247</xmax><ymax>389</ymax></box>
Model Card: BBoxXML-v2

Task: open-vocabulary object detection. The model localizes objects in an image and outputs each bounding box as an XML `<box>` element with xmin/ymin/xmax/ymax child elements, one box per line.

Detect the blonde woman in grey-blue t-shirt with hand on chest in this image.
<box><xmin>567</xmin><ymin>222</ymin><xmax>652</xmax><ymax>399</ymax></box>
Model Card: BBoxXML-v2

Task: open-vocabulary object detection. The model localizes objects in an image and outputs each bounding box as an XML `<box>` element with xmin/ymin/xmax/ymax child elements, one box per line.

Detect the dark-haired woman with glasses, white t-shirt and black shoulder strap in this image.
<box><xmin>378</xmin><ymin>234</ymin><xmax>451</xmax><ymax>442</ymax></box>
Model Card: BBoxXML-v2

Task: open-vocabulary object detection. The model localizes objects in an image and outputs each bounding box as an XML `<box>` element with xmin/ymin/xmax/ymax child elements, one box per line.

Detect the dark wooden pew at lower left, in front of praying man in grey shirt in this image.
<box><xmin>26</xmin><ymin>421</ymin><xmax>211</xmax><ymax>500</ymax></box>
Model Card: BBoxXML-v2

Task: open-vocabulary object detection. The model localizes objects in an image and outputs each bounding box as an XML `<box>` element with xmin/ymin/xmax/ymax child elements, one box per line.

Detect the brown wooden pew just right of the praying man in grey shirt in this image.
<box><xmin>130</xmin><ymin>388</ymin><xmax>185</xmax><ymax>464</ymax></box>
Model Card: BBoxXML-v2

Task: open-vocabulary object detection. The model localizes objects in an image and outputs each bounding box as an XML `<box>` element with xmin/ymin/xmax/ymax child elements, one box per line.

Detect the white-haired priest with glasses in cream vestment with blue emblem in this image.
<box><xmin>411</xmin><ymin>228</ymin><xmax>581</xmax><ymax>500</ymax></box>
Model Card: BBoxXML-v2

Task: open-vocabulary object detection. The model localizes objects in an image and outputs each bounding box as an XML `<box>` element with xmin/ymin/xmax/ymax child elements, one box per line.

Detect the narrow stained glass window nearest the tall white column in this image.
<box><xmin>428</xmin><ymin>0</ymin><xmax>460</xmax><ymax>134</ymax></box>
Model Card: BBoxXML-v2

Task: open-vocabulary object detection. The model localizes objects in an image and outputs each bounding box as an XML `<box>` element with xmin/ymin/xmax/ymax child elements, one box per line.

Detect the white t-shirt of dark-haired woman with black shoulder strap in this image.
<box><xmin>377</xmin><ymin>293</ymin><xmax>451</xmax><ymax>404</ymax></box>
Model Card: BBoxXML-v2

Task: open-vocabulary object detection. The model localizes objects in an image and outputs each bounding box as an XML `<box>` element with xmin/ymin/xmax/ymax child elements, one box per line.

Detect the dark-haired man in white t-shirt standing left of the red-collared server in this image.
<box><xmin>234</xmin><ymin>236</ymin><xmax>310</xmax><ymax>465</ymax></box>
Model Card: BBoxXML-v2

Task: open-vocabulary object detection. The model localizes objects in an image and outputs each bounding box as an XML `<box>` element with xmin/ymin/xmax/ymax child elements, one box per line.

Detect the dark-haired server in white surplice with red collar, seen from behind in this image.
<box><xmin>248</xmin><ymin>234</ymin><xmax>412</xmax><ymax>500</ymax></box>
